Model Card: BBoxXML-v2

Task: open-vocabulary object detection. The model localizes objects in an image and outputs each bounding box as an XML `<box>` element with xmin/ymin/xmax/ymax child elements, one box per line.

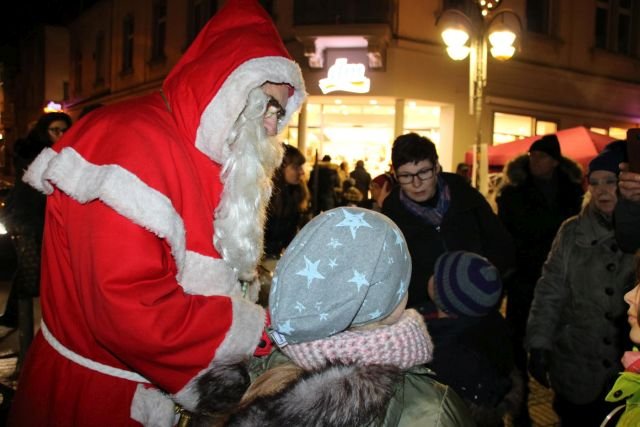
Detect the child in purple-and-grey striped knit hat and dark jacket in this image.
<box><xmin>427</xmin><ymin>251</ymin><xmax>524</xmax><ymax>427</ymax></box>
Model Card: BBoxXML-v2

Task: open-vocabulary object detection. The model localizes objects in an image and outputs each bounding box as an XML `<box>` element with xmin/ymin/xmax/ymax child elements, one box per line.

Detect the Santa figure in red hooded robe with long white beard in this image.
<box><xmin>9</xmin><ymin>0</ymin><xmax>305</xmax><ymax>426</ymax></box>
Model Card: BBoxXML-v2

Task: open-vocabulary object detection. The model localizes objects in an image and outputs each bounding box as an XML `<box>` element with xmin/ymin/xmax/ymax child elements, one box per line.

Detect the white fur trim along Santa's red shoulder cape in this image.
<box><xmin>23</xmin><ymin>147</ymin><xmax>240</xmax><ymax>296</ymax></box>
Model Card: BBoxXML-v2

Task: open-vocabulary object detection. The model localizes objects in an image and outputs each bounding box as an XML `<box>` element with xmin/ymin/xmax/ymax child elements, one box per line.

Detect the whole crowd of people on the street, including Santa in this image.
<box><xmin>0</xmin><ymin>0</ymin><xmax>640</xmax><ymax>427</ymax></box>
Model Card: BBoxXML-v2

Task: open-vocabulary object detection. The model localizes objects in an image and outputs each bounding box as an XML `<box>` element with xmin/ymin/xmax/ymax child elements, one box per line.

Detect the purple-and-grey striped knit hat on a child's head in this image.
<box><xmin>434</xmin><ymin>251</ymin><xmax>502</xmax><ymax>317</ymax></box>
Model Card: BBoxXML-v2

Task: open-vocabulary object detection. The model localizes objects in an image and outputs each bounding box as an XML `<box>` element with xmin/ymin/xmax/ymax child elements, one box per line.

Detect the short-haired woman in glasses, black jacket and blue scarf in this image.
<box><xmin>382</xmin><ymin>133</ymin><xmax>515</xmax><ymax>318</ymax></box>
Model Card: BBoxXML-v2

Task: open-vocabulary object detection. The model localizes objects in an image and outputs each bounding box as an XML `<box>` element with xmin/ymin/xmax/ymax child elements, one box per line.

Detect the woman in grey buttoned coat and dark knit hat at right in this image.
<box><xmin>525</xmin><ymin>141</ymin><xmax>636</xmax><ymax>427</ymax></box>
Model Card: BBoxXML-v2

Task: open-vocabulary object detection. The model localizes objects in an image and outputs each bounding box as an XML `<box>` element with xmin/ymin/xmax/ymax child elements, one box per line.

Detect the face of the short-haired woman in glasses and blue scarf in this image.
<box><xmin>395</xmin><ymin>160</ymin><xmax>440</xmax><ymax>203</ymax></box>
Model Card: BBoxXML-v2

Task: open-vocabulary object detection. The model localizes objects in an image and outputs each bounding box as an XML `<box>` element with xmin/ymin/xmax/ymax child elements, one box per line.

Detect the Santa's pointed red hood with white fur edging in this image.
<box><xmin>162</xmin><ymin>0</ymin><xmax>305</xmax><ymax>163</ymax></box>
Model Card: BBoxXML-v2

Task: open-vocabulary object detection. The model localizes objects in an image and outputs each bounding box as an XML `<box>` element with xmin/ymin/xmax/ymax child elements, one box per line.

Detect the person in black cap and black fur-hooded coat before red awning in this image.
<box><xmin>496</xmin><ymin>134</ymin><xmax>584</xmax><ymax>426</ymax></box>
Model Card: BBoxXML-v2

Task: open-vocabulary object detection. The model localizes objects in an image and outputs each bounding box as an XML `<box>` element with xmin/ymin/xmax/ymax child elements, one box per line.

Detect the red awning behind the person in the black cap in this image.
<box><xmin>465</xmin><ymin>126</ymin><xmax>614</xmax><ymax>170</ymax></box>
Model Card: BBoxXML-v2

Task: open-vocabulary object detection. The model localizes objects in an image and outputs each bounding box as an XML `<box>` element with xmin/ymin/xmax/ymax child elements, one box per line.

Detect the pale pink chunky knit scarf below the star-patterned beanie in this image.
<box><xmin>282</xmin><ymin>310</ymin><xmax>433</xmax><ymax>370</ymax></box>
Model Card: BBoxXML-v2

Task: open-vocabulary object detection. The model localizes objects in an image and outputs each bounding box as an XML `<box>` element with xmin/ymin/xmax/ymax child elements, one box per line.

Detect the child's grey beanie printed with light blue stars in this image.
<box><xmin>269</xmin><ymin>207</ymin><xmax>411</xmax><ymax>347</ymax></box>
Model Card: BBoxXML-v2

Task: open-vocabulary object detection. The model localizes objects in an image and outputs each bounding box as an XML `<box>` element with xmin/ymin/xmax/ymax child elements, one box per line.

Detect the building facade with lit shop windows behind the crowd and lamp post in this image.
<box><xmin>1</xmin><ymin>0</ymin><xmax>640</xmax><ymax>181</ymax></box>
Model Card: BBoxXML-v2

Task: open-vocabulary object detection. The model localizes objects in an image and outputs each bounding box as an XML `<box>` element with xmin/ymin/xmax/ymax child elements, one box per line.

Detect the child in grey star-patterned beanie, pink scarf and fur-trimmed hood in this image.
<box><xmin>222</xmin><ymin>207</ymin><xmax>474</xmax><ymax>427</ymax></box>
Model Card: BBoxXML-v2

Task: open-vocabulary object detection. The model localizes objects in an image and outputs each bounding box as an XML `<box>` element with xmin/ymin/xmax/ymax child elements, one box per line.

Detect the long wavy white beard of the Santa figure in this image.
<box><xmin>213</xmin><ymin>88</ymin><xmax>283</xmax><ymax>280</ymax></box>
